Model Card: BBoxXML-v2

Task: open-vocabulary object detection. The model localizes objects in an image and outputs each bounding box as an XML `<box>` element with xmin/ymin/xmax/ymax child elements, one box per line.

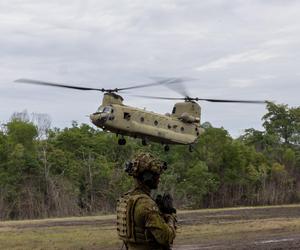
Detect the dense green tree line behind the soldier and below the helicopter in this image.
<box><xmin>0</xmin><ymin>102</ymin><xmax>300</xmax><ymax>219</ymax></box>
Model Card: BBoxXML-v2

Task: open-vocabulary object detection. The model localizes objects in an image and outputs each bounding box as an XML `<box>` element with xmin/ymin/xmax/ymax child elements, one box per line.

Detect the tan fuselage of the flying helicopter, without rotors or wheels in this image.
<box><xmin>90</xmin><ymin>94</ymin><xmax>201</xmax><ymax>145</ymax></box>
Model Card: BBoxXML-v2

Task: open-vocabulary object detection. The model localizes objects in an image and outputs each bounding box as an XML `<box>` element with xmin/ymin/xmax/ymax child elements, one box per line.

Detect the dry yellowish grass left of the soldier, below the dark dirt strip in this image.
<box><xmin>0</xmin><ymin>226</ymin><xmax>119</xmax><ymax>250</ymax></box>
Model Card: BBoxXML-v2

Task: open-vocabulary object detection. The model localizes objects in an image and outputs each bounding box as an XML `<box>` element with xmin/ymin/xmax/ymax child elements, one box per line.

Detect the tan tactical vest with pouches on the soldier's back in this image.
<box><xmin>117</xmin><ymin>194</ymin><xmax>153</xmax><ymax>244</ymax></box>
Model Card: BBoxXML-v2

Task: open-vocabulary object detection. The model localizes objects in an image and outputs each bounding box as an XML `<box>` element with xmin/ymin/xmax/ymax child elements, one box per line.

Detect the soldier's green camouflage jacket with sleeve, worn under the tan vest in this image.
<box><xmin>118</xmin><ymin>186</ymin><xmax>175</xmax><ymax>250</ymax></box>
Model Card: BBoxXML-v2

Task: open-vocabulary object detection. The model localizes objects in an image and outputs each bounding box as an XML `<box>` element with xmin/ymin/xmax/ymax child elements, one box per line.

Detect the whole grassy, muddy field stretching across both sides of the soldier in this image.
<box><xmin>0</xmin><ymin>205</ymin><xmax>300</xmax><ymax>250</ymax></box>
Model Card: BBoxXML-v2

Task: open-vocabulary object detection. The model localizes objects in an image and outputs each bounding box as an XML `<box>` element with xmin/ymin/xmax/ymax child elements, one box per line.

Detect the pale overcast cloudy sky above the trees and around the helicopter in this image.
<box><xmin>0</xmin><ymin>0</ymin><xmax>300</xmax><ymax>137</ymax></box>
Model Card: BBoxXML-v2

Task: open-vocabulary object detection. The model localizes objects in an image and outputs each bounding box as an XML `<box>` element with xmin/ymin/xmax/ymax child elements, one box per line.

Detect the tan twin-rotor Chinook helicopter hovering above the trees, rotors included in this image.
<box><xmin>15</xmin><ymin>78</ymin><xmax>265</xmax><ymax>151</ymax></box>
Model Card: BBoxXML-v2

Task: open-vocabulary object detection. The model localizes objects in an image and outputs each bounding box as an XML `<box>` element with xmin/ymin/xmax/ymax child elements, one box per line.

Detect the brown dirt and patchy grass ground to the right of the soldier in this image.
<box><xmin>174</xmin><ymin>205</ymin><xmax>300</xmax><ymax>250</ymax></box>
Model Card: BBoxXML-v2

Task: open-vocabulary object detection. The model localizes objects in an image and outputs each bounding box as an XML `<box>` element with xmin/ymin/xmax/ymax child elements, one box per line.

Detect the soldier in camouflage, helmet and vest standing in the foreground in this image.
<box><xmin>117</xmin><ymin>153</ymin><xmax>177</xmax><ymax>250</ymax></box>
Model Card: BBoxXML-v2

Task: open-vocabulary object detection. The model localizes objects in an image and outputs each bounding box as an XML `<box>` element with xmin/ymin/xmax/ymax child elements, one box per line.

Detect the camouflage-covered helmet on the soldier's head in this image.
<box><xmin>125</xmin><ymin>153</ymin><xmax>167</xmax><ymax>178</ymax></box>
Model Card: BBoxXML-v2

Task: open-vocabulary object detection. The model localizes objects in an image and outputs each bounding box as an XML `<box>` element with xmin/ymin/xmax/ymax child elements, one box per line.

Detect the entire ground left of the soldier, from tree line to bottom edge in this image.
<box><xmin>0</xmin><ymin>215</ymin><xmax>120</xmax><ymax>250</ymax></box>
